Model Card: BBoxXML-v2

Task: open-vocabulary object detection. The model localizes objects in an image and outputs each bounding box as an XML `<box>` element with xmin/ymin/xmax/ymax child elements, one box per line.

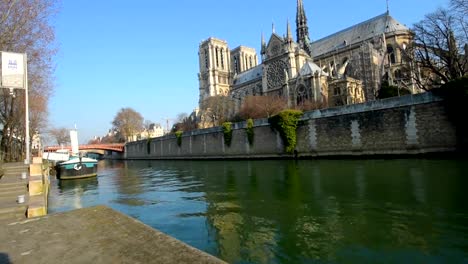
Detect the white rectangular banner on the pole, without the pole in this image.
<box><xmin>1</xmin><ymin>52</ymin><xmax>25</xmax><ymax>89</ymax></box>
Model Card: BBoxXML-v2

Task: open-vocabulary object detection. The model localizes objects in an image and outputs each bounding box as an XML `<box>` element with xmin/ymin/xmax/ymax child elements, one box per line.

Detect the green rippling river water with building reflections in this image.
<box><xmin>49</xmin><ymin>159</ymin><xmax>468</xmax><ymax>263</ymax></box>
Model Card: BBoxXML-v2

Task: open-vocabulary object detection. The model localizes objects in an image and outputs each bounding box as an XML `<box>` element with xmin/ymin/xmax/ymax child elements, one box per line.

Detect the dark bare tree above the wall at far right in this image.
<box><xmin>404</xmin><ymin>3</ymin><xmax>468</xmax><ymax>90</ymax></box>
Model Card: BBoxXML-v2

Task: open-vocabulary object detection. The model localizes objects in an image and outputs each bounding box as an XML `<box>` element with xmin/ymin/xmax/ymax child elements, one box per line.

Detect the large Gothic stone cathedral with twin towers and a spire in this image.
<box><xmin>198</xmin><ymin>0</ymin><xmax>415</xmax><ymax>111</ymax></box>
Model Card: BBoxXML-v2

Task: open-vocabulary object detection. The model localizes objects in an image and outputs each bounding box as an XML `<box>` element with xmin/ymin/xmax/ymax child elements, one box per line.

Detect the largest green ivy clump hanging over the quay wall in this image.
<box><xmin>268</xmin><ymin>109</ymin><xmax>302</xmax><ymax>154</ymax></box>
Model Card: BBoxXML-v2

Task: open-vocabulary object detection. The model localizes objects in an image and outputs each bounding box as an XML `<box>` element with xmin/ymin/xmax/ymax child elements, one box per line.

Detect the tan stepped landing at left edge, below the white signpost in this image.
<box><xmin>0</xmin><ymin>163</ymin><xmax>29</xmax><ymax>223</ymax></box>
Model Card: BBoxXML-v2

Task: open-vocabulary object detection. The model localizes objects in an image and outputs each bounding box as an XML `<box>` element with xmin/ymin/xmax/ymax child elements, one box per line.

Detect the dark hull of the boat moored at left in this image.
<box><xmin>56</xmin><ymin>162</ymin><xmax>97</xmax><ymax>180</ymax></box>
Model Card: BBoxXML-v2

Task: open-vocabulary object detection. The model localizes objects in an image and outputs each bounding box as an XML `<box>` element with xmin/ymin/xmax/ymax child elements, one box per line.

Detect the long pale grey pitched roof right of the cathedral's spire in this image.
<box><xmin>311</xmin><ymin>12</ymin><xmax>409</xmax><ymax>57</ymax></box>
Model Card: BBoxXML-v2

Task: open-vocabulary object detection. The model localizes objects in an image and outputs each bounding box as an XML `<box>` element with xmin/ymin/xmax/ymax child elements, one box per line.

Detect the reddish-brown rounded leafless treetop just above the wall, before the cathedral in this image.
<box><xmin>239</xmin><ymin>95</ymin><xmax>288</xmax><ymax>119</ymax></box>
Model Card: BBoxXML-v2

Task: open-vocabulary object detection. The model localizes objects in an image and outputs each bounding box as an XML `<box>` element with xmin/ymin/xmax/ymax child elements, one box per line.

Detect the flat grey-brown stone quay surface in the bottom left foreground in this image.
<box><xmin>0</xmin><ymin>206</ymin><xmax>224</xmax><ymax>264</ymax></box>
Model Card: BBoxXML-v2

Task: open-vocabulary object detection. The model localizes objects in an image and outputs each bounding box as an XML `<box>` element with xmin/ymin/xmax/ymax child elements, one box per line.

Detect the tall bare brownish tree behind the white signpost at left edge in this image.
<box><xmin>0</xmin><ymin>0</ymin><xmax>58</xmax><ymax>161</ymax></box>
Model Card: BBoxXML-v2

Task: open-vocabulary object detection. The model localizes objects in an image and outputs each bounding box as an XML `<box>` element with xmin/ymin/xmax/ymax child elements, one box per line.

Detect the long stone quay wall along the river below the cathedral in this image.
<box><xmin>124</xmin><ymin>93</ymin><xmax>457</xmax><ymax>159</ymax></box>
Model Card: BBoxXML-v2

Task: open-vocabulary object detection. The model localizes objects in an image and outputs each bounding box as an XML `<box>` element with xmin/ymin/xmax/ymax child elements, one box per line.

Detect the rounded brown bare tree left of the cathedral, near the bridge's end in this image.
<box><xmin>112</xmin><ymin>108</ymin><xmax>143</xmax><ymax>141</ymax></box>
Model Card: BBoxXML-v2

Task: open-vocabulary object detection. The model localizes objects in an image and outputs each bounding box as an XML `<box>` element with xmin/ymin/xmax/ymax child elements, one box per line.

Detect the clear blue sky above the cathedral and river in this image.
<box><xmin>49</xmin><ymin>0</ymin><xmax>448</xmax><ymax>143</ymax></box>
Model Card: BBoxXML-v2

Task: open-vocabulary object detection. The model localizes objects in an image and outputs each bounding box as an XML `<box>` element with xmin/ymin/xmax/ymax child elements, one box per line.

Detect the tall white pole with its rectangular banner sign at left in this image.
<box><xmin>0</xmin><ymin>51</ymin><xmax>31</xmax><ymax>164</ymax></box>
